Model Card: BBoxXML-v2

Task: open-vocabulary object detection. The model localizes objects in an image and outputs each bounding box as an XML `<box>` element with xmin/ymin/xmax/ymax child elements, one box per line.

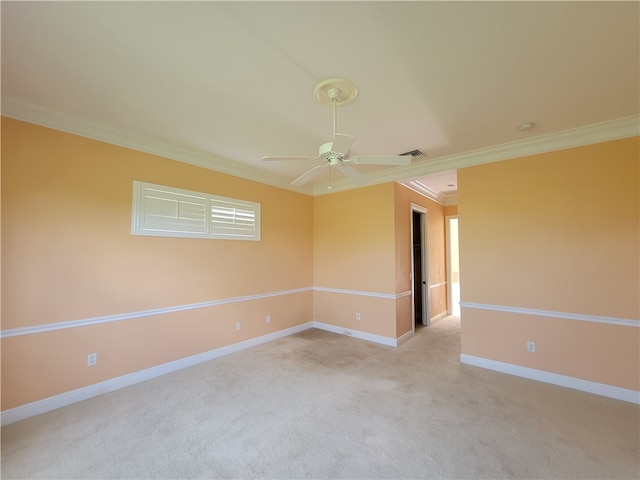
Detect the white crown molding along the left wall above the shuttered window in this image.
<box><xmin>2</xmin><ymin>98</ymin><xmax>311</xmax><ymax>195</ymax></box>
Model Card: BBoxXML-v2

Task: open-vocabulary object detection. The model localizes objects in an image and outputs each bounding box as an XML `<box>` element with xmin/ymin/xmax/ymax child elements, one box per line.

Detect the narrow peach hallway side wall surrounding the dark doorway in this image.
<box><xmin>394</xmin><ymin>183</ymin><xmax>447</xmax><ymax>337</ymax></box>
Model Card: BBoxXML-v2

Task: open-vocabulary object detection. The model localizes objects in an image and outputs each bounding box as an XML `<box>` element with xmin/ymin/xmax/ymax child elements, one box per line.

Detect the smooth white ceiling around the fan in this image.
<box><xmin>1</xmin><ymin>1</ymin><xmax>640</xmax><ymax>194</ymax></box>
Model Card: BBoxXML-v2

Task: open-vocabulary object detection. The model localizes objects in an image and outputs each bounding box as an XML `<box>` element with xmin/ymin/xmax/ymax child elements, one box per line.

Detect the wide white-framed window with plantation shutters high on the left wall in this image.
<box><xmin>131</xmin><ymin>181</ymin><xmax>260</xmax><ymax>240</ymax></box>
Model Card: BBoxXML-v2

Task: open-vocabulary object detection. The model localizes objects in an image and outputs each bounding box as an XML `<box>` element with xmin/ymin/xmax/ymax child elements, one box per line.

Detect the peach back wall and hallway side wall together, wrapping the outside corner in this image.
<box><xmin>314</xmin><ymin>183</ymin><xmax>446</xmax><ymax>338</ymax></box>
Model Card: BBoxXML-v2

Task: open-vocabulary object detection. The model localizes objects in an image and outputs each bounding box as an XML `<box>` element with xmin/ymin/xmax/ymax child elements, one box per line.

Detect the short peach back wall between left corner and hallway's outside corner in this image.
<box><xmin>313</xmin><ymin>183</ymin><xmax>396</xmax><ymax>339</ymax></box>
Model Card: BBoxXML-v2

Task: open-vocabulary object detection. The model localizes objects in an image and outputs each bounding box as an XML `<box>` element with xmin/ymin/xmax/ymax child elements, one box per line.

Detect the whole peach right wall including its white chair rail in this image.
<box><xmin>458</xmin><ymin>137</ymin><xmax>640</xmax><ymax>391</ymax></box>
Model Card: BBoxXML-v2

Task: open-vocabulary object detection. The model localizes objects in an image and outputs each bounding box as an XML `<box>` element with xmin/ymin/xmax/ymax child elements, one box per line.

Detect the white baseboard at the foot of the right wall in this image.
<box><xmin>460</xmin><ymin>353</ymin><xmax>640</xmax><ymax>404</ymax></box>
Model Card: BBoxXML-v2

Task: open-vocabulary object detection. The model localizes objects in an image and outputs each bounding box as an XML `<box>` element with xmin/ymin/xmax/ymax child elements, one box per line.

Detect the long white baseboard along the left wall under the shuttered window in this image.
<box><xmin>0</xmin><ymin>322</ymin><xmax>313</xmax><ymax>426</ymax></box>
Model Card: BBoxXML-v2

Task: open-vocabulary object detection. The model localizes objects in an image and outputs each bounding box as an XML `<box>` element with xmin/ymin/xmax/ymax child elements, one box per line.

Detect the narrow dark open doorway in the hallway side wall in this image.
<box><xmin>411</xmin><ymin>204</ymin><xmax>429</xmax><ymax>330</ymax></box>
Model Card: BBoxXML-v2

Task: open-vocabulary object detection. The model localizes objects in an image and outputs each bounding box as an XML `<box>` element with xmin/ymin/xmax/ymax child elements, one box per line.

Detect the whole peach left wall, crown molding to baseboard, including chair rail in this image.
<box><xmin>1</xmin><ymin>118</ymin><xmax>313</xmax><ymax>410</ymax></box>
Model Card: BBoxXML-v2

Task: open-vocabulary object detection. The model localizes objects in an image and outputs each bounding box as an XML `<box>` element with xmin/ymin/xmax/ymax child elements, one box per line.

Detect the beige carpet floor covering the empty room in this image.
<box><xmin>2</xmin><ymin>317</ymin><xmax>640</xmax><ymax>479</ymax></box>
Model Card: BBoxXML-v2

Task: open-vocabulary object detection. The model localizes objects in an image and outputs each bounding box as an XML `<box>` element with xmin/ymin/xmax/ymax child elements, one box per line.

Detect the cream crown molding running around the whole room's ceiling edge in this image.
<box><xmin>2</xmin><ymin>98</ymin><xmax>640</xmax><ymax>198</ymax></box>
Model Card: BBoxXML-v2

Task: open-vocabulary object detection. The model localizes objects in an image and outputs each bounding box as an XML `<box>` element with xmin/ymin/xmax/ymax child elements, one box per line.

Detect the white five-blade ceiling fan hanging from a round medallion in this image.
<box><xmin>262</xmin><ymin>78</ymin><xmax>411</xmax><ymax>188</ymax></box>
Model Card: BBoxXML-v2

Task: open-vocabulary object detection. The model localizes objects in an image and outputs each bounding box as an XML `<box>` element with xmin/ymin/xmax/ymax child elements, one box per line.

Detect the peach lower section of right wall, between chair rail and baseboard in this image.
<box><xmin>462</xmin><ymin>309</ymin><xmax>640</xmax><ymax>391</ymax></box>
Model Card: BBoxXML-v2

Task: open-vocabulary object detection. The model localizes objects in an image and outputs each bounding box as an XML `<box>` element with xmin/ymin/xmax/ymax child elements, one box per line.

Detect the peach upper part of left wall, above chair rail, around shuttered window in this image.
<box><xmin>2</xmin><ymin>119</ymin><xmax>312</xmax><ymax>329</ymax></box>
